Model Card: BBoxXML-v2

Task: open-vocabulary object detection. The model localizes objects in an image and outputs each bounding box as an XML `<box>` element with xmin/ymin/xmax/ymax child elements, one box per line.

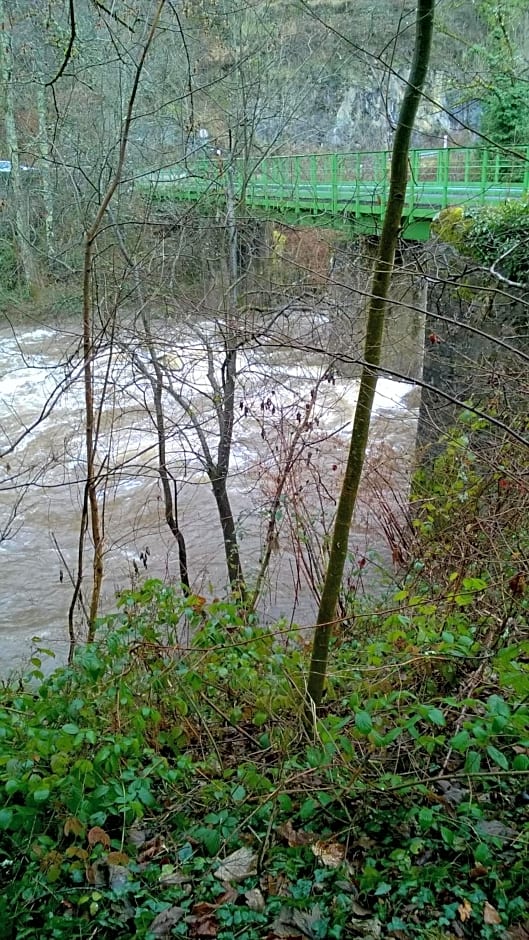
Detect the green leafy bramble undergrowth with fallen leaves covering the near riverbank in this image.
<box><xmin>0</xmin><ymin>416</ymin><xmax>529</xmax><ymax>940</ymax></box>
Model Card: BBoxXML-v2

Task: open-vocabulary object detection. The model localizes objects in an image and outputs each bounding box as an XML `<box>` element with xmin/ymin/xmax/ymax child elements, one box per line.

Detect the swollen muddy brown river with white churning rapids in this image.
<box><xmin>0</xmin><ymin>317</ymin><xmax>418</xmax><ymax>675</ymax></box>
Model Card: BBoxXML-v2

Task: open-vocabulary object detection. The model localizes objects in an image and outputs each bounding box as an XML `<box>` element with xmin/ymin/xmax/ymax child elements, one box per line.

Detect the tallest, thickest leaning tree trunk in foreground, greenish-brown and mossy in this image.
<box><xmin>307</xmin><ymin>0</ymin><xmax>434</xmax><ymax>708</ymax></box>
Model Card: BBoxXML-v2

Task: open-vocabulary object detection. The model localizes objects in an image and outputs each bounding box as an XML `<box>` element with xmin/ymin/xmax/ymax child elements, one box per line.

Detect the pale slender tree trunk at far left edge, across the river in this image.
<box><xmin>0</xmin><ymin>0</ymin><xmax>38</xmax><ymax>285</ymax></box>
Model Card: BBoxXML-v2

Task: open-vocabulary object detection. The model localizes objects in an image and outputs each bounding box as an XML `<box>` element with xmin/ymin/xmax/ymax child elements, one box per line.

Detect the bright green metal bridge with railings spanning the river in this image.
<box><xmin>142</xmin><ymin>147</ymin><xmax>529</xmax><ymax>241</ymax></box>
